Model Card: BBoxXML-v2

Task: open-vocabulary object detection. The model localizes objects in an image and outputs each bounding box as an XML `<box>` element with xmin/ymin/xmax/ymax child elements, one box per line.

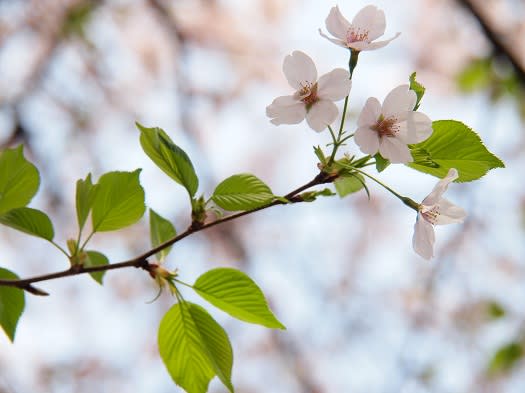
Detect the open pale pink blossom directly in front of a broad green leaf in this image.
<box><xmin>355</xmin><ymin>85</ymin><xmax>432</xmax><ymax>164</ymax></box>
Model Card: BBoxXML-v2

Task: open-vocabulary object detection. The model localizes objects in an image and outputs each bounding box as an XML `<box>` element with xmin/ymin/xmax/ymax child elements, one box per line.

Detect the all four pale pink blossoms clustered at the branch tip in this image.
<box><xmin>266</xmin><ymin>5</ymin><xmax>466</xmax><ymax>259</ymax></box>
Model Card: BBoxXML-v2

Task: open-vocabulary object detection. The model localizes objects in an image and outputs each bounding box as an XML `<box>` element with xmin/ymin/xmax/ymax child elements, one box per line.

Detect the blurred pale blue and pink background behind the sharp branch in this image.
<box><xmin>0</xmin><ymin>0</ymin><xmax>525</xmax><ymax>393</ymax></box>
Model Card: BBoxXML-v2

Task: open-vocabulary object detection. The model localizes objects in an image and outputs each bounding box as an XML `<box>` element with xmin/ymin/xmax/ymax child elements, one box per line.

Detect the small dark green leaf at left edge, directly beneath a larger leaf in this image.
<box><xmin>0</xmin><ymin>207</ymin><xmax>55</xmax><ymax>241</ymax></box>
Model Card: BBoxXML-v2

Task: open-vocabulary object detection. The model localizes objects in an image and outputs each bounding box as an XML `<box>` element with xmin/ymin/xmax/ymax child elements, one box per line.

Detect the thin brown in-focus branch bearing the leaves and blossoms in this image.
<box><xmin>0</xmin><ymin>172</ymin><xmax>337</xmax><ymax>296</ymax></box>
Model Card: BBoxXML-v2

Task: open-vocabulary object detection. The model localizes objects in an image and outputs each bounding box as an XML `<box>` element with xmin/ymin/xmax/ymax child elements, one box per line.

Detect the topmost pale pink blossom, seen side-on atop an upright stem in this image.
<box><xmin>319</xmin><ymin>5</ymin><xmax>401</xmax><ymax>52</ymax></box>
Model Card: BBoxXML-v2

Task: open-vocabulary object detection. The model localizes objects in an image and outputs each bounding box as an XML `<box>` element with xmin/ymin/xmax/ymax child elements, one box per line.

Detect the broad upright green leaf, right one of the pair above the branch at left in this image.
<box><xmin>91</xmin><ymin>169</ymin><xmax>146</xmax><ymax>232</ymax></box>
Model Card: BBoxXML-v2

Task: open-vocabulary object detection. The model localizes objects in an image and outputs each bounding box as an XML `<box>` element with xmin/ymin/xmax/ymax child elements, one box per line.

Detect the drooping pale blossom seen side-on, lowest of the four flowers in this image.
<box><xmin>412</xmin><ymin>168</ymin><xmax>467</xmax><ymax>259</ymax></box>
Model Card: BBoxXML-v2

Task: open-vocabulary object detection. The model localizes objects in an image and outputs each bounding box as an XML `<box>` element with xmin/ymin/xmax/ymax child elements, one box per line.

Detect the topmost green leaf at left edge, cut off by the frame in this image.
<box><xmin>0</xmin><ymin>145</ymin><xmax>40</xmax><ymax>214</ymax></box>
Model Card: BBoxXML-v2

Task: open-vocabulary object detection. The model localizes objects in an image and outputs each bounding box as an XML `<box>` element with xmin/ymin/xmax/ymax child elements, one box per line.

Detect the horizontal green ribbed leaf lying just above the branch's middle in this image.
<box><xmin>211</xmin><ymin>173</ymin><xmax>274</xmax><ymax>211</ymax></box>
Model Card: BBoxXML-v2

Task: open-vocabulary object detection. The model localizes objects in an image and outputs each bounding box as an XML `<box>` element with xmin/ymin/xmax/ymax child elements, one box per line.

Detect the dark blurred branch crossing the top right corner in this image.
<box><xmin>458</xmin><ymin>0</ymin><xmax>525</xmax><ymax>87</ymax></box>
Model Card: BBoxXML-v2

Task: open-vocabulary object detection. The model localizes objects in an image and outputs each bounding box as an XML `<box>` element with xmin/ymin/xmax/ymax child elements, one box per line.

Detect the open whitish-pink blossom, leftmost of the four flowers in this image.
<box><xmin>266</xmin><ymin>51</ymin><xmax>352</xmax><ymax>132</ymax></box>
